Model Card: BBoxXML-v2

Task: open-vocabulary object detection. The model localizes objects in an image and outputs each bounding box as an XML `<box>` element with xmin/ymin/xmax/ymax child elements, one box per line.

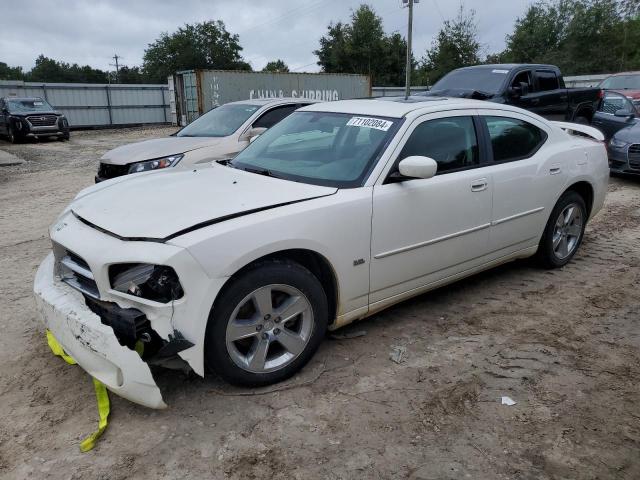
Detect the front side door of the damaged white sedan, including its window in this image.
<box><xmin>369</xmin><ymin>111</ymin><xmax>493</xmax><ymax>308</ymax></box>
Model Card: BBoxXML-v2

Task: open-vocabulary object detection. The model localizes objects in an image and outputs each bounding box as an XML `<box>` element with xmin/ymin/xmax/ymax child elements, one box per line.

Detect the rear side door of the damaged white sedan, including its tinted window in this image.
<box><xmin>480</xmin><ymin>110</ymin><xmax>567</xmax><ymax>258</ymax></box>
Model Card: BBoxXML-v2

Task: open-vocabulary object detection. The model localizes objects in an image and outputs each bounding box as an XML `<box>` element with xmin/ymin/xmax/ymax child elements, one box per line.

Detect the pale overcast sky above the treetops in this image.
<box><xmin>0</xmin><ymin>0</ymin><xmax>531</xmax><ymax>75</ymax></box>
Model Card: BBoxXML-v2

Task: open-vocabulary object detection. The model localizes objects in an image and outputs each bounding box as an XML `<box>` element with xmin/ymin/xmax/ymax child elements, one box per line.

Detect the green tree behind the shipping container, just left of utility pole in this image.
<box><xmin>313</xmin><ymin>5</ymin><xmax>407</xmax><ymax>85</ymax></box>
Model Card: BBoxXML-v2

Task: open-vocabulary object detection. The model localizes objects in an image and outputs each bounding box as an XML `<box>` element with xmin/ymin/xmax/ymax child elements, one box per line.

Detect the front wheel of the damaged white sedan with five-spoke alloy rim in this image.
<box><xmin>205</xmin><ymin>260</ymin><xmax>328</xmax><ymax>386</ymax></box>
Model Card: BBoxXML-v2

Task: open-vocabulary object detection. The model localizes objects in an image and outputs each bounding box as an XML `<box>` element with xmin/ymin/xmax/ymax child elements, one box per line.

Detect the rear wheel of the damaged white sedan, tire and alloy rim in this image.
<box><xmin>538</xmin><ymin>190</ymin><xmax>587</xmax><ymax>268</ymax></box>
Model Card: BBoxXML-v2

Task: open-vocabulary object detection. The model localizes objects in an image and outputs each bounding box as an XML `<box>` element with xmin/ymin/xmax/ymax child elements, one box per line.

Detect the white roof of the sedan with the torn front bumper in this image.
<box><xmin>298</xmin><ymin>96</ymin><xmax>521</xmax><ymax>118</ymax></box>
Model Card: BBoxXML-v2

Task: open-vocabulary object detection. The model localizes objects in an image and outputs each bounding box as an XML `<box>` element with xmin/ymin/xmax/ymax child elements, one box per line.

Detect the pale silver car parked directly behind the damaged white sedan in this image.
<box><xmin>95</xmin><ymin>98</ymin><xmax>314</xmax><ymax>183</ymax></box>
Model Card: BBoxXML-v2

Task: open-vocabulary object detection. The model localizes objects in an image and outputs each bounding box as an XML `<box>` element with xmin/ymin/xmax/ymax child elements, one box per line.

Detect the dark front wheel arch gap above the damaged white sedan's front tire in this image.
<box><xmin>212</xmin><ymin>248</ymin><xmax>339</xmax><ymax>325</ymax></box>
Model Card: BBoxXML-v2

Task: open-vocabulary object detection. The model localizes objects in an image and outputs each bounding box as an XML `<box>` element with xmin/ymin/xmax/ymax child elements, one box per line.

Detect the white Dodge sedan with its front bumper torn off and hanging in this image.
<box><xmin>35</xmin><ymin>97</ymin><xmax>609</xmax><ymax>408</ymax></box>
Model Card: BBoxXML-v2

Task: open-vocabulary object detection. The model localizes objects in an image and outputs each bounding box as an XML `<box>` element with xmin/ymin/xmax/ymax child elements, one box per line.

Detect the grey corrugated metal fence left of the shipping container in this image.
<box><xmin>0</xmin><ymin>80</ymin><xmax>171</xmax><ymax>128</ymax></box>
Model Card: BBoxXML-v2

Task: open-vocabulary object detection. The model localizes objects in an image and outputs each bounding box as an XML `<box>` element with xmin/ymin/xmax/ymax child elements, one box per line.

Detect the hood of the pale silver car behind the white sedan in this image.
<box><xmin>100</xmin><ymin>137</ymin><xmax>222</xmax><ymax>165</ymax></box>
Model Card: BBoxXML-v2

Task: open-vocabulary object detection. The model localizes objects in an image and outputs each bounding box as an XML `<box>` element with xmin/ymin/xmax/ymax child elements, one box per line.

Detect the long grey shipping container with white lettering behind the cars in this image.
<box><xmin>172</xmin><ymin>70</ymin><xmax>371</xmax><ymax>125</ymax></box>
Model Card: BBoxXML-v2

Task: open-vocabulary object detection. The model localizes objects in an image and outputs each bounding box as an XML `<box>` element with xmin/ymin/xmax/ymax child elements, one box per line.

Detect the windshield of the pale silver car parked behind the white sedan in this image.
<box><xmin>177</xmin><ymin>103</ymin><xmax>260</xmax><ymax>137</ymax></box>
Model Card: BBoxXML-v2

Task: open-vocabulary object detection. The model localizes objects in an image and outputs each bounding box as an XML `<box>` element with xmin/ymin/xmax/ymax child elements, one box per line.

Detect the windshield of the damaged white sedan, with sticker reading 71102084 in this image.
<box><xmin>231</xmin><ymin>112</ymin><xmax>400</xmax><ymax>188</ymax></box>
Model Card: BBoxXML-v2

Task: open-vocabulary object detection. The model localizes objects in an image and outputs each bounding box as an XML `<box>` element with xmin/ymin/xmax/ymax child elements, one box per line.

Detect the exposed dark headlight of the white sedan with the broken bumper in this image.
<box><xmin>109</xmin><ymin>263</ymin><xmax>184</xmax><ymax>303</ymax></box>
